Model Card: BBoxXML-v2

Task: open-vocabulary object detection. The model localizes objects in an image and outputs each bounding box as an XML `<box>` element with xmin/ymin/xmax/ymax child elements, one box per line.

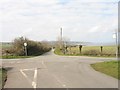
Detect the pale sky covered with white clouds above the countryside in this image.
<box><xmin>0</xmin><ymin>0</ymin><xmax>119</xmax><ymax>42</ymax></box>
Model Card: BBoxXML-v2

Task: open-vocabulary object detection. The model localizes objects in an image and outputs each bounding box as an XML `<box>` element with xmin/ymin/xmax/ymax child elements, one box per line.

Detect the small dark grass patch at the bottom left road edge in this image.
<box><xmin>0</xmin><ymin>68</ymin><xmax>7</xmax><ymax>88</ymax></box>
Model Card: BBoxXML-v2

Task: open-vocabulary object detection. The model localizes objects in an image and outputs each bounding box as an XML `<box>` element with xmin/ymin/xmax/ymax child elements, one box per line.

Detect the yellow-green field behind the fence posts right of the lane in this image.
<box><xmin>55</xmin><ymin>46</ymin><xmax>116</xmax><ymax>57</ymax></box>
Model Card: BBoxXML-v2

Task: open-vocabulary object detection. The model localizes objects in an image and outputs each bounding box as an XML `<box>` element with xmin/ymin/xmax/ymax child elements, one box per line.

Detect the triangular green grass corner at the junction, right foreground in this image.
<box><xmin>91</xmin><ymin>61</ymin><xmax>120</xmax><ymax>79</ymax></box>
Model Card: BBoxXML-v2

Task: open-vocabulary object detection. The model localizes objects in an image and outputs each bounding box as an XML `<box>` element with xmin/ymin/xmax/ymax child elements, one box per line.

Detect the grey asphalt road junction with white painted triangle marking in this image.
<box><xmin>3</xmin><ymin>51</ymin><xmax>118</xmax><ymax>88</ymax></box>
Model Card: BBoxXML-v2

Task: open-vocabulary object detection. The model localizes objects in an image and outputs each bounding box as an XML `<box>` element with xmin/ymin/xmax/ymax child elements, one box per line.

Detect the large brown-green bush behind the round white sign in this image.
<box><xmin>8</xmin><ymin>37</ymin><xmax>50</xmax><ymax>56</ymax></box>
